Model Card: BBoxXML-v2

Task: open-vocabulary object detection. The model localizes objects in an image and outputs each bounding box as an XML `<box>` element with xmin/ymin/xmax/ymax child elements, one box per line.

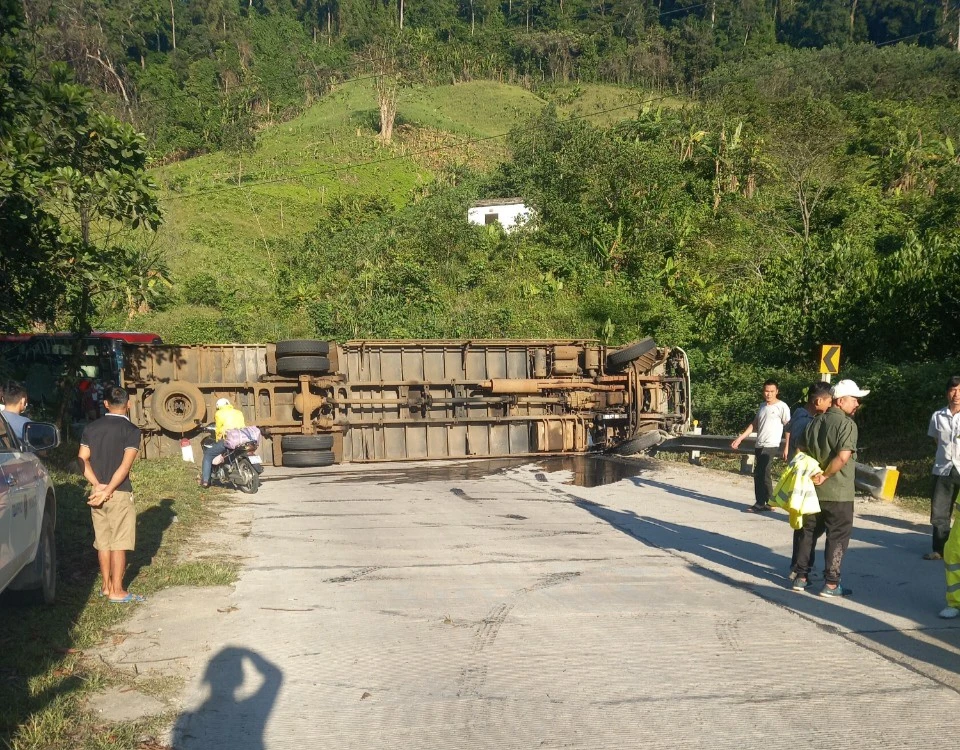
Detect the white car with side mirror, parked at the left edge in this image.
<box><xmin>0</xmin><ymin>416</ymin><xmax>60</xmax><ymax>604</ymax></box>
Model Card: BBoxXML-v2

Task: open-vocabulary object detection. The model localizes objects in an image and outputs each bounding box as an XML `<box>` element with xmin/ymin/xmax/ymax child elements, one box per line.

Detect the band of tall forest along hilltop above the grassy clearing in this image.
<box><xmin>20</xmin><ymin>0</ymin><xmax>960</xmax><ymax>157</ymax></box>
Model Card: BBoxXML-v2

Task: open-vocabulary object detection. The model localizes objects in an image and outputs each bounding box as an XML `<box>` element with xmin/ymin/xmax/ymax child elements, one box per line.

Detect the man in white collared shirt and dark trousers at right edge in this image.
<box><xmin>923</xmin><ymin>375</ymin><xmax>960</xmax><ymax>560</ymax></box>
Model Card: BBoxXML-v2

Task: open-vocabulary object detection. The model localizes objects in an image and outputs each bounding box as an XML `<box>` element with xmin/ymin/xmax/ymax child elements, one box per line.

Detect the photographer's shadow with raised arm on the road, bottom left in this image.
<box><xmin>172</xmin><ymin>646</ymin><xmax>283</xmax><ymax>750</ymax></box>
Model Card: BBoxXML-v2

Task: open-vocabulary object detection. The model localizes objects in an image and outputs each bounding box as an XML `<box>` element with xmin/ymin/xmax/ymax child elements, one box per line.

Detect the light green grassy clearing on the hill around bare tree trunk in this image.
<box><xmin>144</xmin><ymin>81</ymin><xmax>660</xmax><ymax>296</ymax></box>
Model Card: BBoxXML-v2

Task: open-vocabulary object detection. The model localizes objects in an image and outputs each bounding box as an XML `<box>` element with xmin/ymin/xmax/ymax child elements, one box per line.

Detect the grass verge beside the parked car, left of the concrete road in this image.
<box><xmin>0</xmin><ymin>450</ymin><xmax>238</xmax><ymax>750</ymax></box>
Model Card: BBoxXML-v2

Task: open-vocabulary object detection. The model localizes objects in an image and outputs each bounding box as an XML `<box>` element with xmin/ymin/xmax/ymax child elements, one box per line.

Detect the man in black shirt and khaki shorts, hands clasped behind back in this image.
<box><xmin>80</xmin><ymin>386</ymin><xmax>143</xmax><ymax>604</ymax></box>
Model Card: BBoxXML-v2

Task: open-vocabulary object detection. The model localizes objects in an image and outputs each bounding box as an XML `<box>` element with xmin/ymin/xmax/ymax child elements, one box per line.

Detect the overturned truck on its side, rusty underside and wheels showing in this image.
<box><xmin>122</xmin><ymin>339</ymin><xmax>690</xmax><ymax>467</ymax></box>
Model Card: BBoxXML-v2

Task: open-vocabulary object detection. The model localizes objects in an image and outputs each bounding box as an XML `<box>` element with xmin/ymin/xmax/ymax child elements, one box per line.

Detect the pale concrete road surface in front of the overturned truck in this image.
<box><xmin>173</xmin><ymin>461</ymin><xmax>960</xmax><ymax>750</ymax></box>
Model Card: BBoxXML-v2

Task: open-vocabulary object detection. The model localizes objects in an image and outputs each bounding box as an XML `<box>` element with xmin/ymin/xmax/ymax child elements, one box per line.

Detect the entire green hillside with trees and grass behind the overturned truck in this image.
<box><xmin>7</xmin><ymin>0</ymin><xmax>960</xmax><ymax>512</ymax></box>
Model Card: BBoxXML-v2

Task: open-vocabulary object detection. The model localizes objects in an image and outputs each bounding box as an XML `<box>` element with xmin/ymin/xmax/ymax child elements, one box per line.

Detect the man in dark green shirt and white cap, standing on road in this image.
<box><xmin>793</xmin><ymin>380</ymin><xmax>870</xmax><ymax>597</ymax></box>
